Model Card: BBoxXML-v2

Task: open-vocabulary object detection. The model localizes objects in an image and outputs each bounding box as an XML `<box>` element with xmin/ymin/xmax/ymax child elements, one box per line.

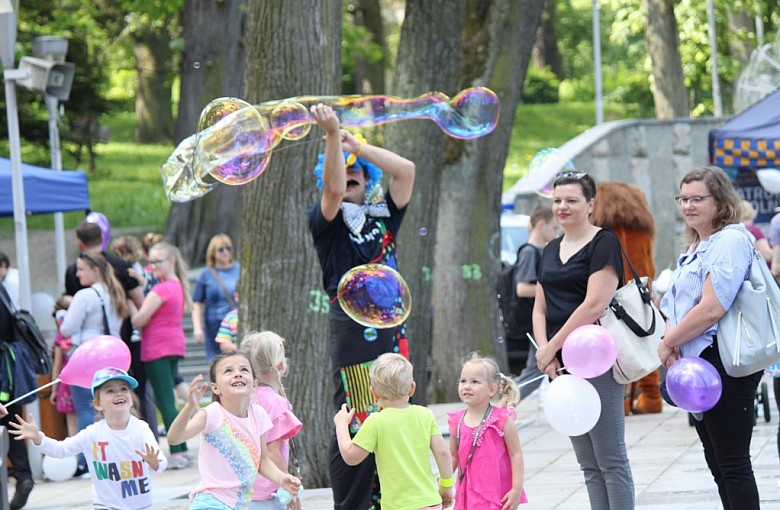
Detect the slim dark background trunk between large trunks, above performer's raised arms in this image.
<box><xmin>355</xmin><ymin>0</ymin><xmax>387</xmax><ymax>94</ymax></box>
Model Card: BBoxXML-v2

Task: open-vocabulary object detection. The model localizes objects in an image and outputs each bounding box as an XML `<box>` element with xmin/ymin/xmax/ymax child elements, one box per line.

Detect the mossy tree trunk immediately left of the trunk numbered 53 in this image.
<box><xmin>385</xmin><ymin>0</ymin><xmax>466</xmax><ymax>403</ymax></box>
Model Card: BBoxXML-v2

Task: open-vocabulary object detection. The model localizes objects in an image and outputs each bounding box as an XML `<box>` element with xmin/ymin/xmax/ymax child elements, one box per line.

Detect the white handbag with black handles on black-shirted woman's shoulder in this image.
<box><xmin>598</xmin><ymin>245</ymin><xmax>666</xmax><ymax>384</ymax></box>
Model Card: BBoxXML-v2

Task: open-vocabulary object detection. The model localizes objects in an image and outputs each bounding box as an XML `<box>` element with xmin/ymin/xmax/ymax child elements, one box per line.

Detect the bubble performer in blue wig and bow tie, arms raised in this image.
<box><xmin>308</xmin><ymin>104</ymin><xmax>415</xmax><ymax>508</ymax></box>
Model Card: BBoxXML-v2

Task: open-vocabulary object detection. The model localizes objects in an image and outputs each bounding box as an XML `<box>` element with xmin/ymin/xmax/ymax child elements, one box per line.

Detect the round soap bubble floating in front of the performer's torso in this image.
<box><xmin>338</xmin><ymin>264</ymin><xmax>412</xmax><ymax>328</ymax></box>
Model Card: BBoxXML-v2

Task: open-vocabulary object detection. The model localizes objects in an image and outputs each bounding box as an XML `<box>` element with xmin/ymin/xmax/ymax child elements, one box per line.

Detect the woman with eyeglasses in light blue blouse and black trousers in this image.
<box><xmin>658</xmin><ymin>167</ymin><xmax>763</xmax><ymax>510</ymax></box>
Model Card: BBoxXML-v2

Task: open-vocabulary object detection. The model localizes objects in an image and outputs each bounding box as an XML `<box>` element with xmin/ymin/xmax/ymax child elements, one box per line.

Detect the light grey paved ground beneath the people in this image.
<box><xmin>11</xmin><ymin>379</ymin><xmax>780</xmax><ymax>510</ymax></box>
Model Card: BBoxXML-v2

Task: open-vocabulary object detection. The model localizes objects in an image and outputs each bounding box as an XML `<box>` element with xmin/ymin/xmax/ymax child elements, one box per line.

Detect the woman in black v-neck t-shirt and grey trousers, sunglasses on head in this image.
<box><xmin>533</xmin><ymin>171</ymin><xmax>634</xmax><ymax>510</ymax></box>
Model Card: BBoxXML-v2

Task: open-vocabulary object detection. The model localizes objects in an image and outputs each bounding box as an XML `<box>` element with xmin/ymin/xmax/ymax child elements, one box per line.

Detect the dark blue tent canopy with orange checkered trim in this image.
<box><xmin>709</xmin><ymin>89</ymin><xmax>780</xmax><ymax>169</ymax></box>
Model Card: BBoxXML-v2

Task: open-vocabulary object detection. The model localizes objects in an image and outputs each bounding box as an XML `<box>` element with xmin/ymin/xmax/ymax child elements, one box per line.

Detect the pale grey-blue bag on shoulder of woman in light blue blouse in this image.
<box><xmin>718</xmin><ymin>251</ymin><xmax>780</xmax><ymax>377</ymax></box>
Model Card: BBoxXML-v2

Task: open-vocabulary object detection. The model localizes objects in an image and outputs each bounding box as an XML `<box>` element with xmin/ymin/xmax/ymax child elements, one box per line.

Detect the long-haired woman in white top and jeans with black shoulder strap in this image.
<box><xmin>60</xmin><ymin>251</ymin><xmax>128</xmax><ymax>475</ymax></box>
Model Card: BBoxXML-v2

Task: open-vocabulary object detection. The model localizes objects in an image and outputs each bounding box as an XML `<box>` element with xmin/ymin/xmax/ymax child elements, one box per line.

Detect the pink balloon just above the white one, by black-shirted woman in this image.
<box><xmin>561</xmin><ymin>324</ymin><xmax>617</xmax><ymax>379</ymax></box>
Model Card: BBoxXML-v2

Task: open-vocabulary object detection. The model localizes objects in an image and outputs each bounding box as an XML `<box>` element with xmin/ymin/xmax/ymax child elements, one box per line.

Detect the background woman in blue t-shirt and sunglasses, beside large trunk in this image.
<box><xmin>192</xmin><ymin>234</ymin><xmax>241</xmax><ymax>361</ymax></box>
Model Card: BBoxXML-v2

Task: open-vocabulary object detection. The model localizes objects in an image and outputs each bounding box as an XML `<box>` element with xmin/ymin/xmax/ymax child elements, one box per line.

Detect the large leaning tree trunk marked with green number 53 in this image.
<box><xmin>429</xmin><ymin>0</ymin><xmax>544</xmax><ymax>402</ymax></box>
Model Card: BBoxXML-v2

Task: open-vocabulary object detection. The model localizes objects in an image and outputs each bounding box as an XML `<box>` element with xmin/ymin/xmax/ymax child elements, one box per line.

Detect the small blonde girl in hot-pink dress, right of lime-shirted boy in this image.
<box><xmin>448</xmin><ymin>354</ymin><xmax>528</xmax><ymax>510</ymax></box>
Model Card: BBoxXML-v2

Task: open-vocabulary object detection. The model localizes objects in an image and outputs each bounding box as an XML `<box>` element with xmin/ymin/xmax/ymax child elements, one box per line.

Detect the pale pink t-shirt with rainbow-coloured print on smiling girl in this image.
<box><xmin>190</xmin><ymin>402</ymin><xmax>271</xmax><ymax>508</ymax></box>
